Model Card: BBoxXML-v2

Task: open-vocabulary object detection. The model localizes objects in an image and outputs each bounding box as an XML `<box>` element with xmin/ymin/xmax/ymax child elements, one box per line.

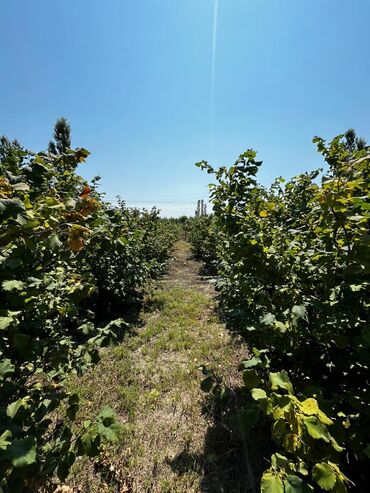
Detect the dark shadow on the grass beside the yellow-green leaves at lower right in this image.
<box><xmin>168</xmin><ymin>389</ymin><xmax>273</xmax><ymax>493</ymax></box>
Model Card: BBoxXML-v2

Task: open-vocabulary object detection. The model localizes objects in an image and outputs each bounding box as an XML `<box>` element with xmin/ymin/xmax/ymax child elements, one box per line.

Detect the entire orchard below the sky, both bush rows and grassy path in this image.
<box><xmin>0</xmin><ymin>132</ymin><xmax>370</xmax><ymax>493</ymax></box>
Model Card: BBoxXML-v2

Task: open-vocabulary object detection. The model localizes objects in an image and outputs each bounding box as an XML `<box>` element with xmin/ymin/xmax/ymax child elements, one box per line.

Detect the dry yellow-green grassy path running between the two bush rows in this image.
<box><xmin>69</xmin><ymin>241</ymin><xmax>250</xmax><ymax>493</ymax></box>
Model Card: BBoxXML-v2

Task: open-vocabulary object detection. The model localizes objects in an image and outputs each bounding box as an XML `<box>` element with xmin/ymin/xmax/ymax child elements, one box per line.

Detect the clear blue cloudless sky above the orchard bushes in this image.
<box><xmin>0</xmin><ymin>0</ymin><xmax>370</xmax><ymax>215</ymax></box>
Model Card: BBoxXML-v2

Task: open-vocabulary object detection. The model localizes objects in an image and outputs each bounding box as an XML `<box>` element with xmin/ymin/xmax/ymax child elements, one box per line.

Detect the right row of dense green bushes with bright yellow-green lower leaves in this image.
<box><xmin>198</xmin><ymin>132</ymin><xmax>370</xmax><ymax>491</ymax></box>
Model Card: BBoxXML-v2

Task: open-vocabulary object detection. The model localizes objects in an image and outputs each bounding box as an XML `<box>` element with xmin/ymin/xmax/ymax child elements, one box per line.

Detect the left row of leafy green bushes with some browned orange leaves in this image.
<box><xmin>0</xmin><ymin>120</ymin><xmax>178</xmax><ymax>493</ymax></box>
